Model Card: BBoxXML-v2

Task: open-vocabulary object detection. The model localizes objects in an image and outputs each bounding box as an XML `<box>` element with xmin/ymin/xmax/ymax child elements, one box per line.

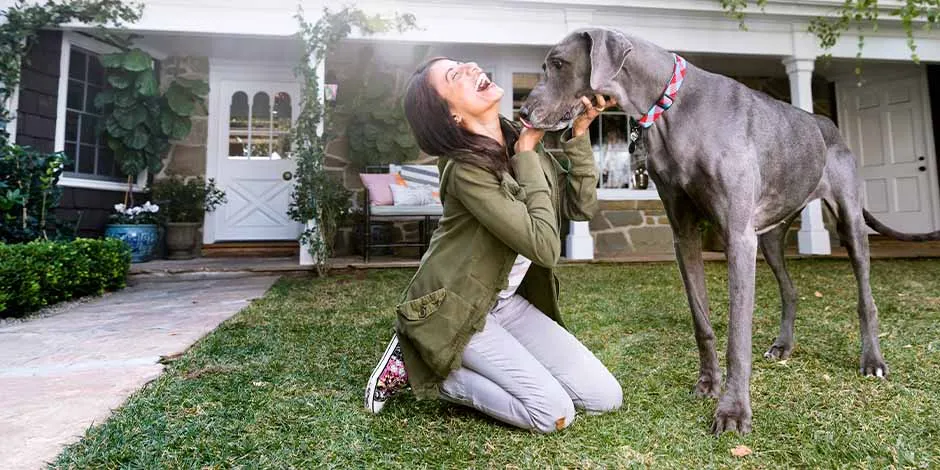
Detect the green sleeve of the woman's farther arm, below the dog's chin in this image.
<box><xmin>559</xmin><ymin>132</ymin><xmax>598</xmax><ymax>221</ymax></box>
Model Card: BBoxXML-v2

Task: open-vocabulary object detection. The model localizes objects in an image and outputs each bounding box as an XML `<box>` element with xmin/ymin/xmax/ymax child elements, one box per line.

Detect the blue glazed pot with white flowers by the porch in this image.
<box><xmin>104</xmin><ymin>201</ymin><xmax>160</xmax><ymax>263</ymax></box>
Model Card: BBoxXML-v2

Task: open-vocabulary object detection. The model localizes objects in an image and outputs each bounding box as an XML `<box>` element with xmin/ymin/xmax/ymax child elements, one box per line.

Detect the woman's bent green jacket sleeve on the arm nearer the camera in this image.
<box><xmin>452</xmin><ymin>151</ymin><xmax>561</xmax><ymax>267</ymax></box>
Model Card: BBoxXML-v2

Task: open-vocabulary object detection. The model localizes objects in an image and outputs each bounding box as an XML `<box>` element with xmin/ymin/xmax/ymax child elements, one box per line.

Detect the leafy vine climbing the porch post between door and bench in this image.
<box><xmin>288</xmin><ymin>7</ymin><xmax>415</xmax><ymax>276</ymax></box>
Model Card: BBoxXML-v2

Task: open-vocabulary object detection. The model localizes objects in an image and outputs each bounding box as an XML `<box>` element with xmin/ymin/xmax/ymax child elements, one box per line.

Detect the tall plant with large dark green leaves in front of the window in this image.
<box><xmin>95</xmin><ymin>48</ymin><xmax>209</xmax><ymax>204</ymax></box>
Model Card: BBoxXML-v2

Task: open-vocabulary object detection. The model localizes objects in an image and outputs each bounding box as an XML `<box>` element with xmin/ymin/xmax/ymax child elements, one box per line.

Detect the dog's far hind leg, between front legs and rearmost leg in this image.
<box><xmin>760</xmin><ymin>218</ymin><xmax>796</xmax><ymax>359</ymax></box>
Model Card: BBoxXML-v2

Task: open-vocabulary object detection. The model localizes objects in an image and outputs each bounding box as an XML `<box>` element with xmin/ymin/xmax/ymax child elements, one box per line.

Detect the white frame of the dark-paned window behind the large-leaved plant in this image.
<box><xmin>55</xmin><ymin>31</ymin><xmax>166</xmax><ymax>192</ymax></box>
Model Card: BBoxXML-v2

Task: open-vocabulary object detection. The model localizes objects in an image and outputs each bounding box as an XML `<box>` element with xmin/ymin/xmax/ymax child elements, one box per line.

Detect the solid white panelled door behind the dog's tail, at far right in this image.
<box><xmin>839</xmin><ymin>76</ymin><xmax>936</xmax><ymax>232</ymax></box>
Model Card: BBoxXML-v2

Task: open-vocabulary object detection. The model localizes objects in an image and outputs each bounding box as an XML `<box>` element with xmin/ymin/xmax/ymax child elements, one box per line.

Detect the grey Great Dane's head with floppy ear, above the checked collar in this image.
<box><xmin>519</xmin><ymin>28</ymin><xmax>633</xmax><ymax>131</ymax></box>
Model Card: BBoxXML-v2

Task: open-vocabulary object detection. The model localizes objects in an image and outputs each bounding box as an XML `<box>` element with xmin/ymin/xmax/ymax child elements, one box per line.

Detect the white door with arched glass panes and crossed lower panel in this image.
<box><xmin>215</xmin><ymin>81</ymin><xmax>301</xmax><ymax>241</ymax></box>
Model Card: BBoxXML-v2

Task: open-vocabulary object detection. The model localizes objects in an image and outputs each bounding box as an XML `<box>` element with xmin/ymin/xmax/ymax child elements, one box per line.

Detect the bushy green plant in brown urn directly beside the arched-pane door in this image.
<box><xmin>151</xmin><ymin>176</ymin><xmax>226</xmax><ymax>259</ymax></box>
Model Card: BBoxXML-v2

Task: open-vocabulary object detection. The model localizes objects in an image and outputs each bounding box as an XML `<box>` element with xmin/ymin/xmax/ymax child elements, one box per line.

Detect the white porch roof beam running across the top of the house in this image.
<box><xmin>53</xmin><ymin>0</ymin><xmax>940</xmax><ymax>62</ymax></box>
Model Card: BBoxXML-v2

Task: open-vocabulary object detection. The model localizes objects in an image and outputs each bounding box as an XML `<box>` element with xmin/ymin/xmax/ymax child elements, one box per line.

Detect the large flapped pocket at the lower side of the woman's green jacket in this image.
<box><xmin>396</xmin><ymin>288</ymin><xmax>473</xmax><ymax>377</ymax></box>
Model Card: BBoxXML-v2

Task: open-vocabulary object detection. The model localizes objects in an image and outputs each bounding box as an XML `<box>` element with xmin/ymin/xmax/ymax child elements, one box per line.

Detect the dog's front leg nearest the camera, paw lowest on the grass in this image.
<box><xmin>713</xmin><ymin>224</ymin><xmax>757</xmax><ymax>434</ymax></box>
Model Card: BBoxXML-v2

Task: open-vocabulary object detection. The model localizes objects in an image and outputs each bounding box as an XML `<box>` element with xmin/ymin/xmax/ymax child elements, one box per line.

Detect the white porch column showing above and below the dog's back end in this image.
<box><xmin>783</xmin><ymin>57</ymin><xmax>832</xmax><ymax>255</ymax></box>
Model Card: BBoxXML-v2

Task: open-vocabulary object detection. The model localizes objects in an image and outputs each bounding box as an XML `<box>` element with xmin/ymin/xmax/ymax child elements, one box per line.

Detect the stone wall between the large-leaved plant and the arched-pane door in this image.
<box><xmin>155</xmin><ymin>57</ymin><xmax>209</xmax><ymax>179</ymax></box>
